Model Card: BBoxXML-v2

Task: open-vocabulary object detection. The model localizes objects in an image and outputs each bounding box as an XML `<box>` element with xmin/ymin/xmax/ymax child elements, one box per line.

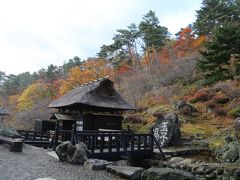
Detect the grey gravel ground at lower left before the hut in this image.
<box><xmin>0</xmin><ymin>145</ymin><xmax>119</xmax><ymax>180</ymax></box>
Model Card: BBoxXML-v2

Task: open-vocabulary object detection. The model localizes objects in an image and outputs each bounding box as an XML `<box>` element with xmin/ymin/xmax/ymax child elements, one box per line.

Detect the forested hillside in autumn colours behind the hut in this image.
<box><xmin>0</xmin><ymin>0</ymin><xmax>240</xmax><ymax>152</ymax></box>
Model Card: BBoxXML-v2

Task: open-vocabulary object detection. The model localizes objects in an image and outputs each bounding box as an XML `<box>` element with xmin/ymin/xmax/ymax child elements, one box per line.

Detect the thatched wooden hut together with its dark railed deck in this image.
<box><xmin>19</xmin><ymin>78</ymin><xmax>164</xmax><ymax>159</ymax></box>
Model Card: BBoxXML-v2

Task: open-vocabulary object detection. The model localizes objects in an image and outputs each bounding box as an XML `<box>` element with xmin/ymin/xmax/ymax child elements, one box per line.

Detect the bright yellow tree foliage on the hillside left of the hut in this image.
<box><xmin>17</xmin><ymin>82</ymin><xmax>48</xmax><ymax>111</ymax></box>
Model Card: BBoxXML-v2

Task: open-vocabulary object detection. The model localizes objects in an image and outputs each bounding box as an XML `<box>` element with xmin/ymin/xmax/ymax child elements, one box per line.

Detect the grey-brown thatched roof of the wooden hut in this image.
<box><xmin>48</xmin><ymin>78</ymin><xmax>135</xmax><ymax>110</ymax></box>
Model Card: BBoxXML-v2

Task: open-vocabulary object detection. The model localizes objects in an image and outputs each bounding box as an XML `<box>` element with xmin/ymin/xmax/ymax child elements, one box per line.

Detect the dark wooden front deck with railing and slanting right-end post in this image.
<box><xmin>73</xmin><ymin>131</ymin><xmax>164</xmax><ymax>159</ymax></box>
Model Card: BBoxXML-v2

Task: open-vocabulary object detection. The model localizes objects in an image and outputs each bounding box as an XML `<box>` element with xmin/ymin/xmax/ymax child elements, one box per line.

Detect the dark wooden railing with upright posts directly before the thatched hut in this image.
<box><xmin>74</xmin><ymin>131</ymin><xmax>153</xmax><ymax>154</ymax></box>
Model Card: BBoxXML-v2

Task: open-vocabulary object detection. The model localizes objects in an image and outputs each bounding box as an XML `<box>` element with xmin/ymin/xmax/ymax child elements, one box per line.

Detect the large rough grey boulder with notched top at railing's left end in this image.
<box><xmin>55</xmin><ymin>141</ymin><xmax>89</xmax><ymax>165</ymax></box>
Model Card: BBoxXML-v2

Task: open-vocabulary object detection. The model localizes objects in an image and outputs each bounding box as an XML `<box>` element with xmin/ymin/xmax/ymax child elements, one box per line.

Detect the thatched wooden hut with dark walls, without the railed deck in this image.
<box><xmin>48</xmin><ymin>78</ymin><xmax>135</xmax><ymax>140</ymax></box>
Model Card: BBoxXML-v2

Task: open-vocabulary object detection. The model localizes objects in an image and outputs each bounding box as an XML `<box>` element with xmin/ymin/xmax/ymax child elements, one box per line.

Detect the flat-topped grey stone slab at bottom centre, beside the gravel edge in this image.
<box><xmin>106</xmin><ymin>165</ymin><xmax>144</xmax><ymax>180</ymax></box>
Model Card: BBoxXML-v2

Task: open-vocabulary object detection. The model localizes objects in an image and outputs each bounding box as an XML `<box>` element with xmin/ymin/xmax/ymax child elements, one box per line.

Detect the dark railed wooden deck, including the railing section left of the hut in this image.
<box><xmin>18</xmin><ymin>131</ymin><xmax>164</xmax><ymax>160</ymax></box>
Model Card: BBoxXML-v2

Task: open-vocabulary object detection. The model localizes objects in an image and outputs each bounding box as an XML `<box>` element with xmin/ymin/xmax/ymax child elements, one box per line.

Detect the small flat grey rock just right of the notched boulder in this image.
<box><xmin>84</xmin><ymin>159</ymin><xmax>112</xmax><ymax>171</ymax></box>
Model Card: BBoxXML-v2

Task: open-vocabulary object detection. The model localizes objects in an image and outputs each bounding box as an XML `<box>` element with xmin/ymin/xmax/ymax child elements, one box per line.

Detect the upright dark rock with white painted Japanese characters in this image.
<box><xmin>153</xmin><ymin>113</ymin><xmax>181</xmax><ymax>147</ymax></box>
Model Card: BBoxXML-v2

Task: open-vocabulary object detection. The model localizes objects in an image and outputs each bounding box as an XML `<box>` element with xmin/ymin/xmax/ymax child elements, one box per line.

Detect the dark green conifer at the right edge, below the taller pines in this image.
<box><xmin>198</xmin><ymin>23</ymin><xmax>240</xmax><ymax>81</ymax></box>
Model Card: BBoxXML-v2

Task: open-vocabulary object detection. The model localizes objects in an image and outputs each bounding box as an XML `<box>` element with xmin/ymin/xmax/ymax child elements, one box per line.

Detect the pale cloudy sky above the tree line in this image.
<box><xmin>0</xmin><ymin>0</ymin><xmax>202</xmax><ymax>74</ymax></box>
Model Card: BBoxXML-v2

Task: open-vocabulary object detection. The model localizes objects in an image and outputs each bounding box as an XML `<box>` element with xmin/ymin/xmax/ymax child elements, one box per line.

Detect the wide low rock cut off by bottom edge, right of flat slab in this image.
<box><xmin>142</xmin><ymin>167</ymin><xmax>197</xmax><ymax>180</ymax></box>
